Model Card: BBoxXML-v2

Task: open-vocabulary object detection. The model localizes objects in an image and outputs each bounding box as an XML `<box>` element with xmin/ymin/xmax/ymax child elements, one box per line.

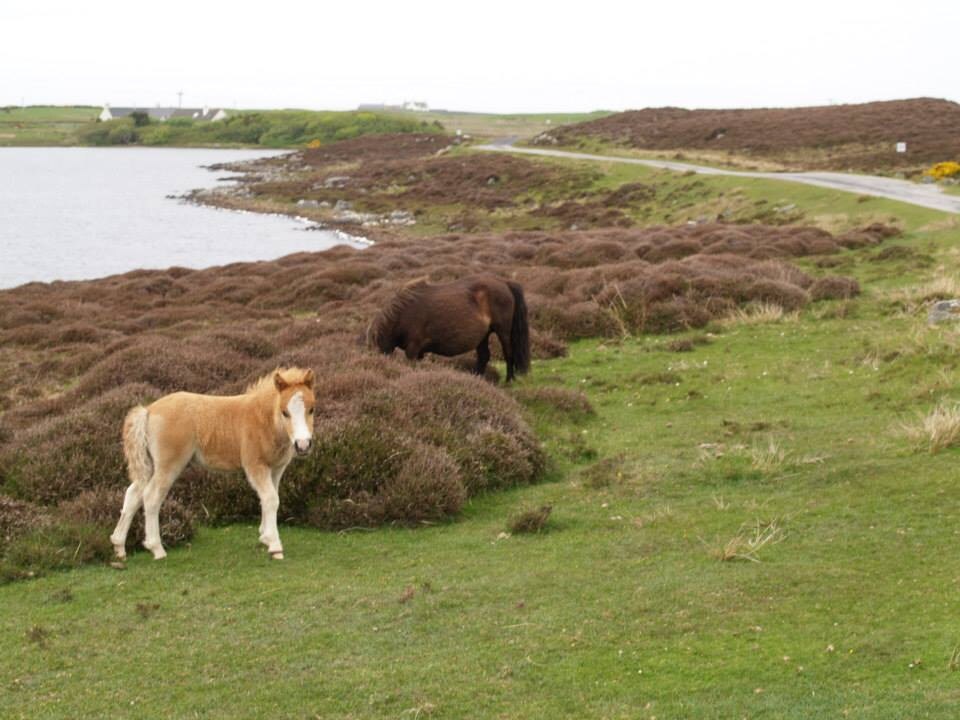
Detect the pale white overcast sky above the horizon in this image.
<box><xmin>0</xmin><ymin>0</ymin><xmax>960</xmax><ymax>112</ymax></box>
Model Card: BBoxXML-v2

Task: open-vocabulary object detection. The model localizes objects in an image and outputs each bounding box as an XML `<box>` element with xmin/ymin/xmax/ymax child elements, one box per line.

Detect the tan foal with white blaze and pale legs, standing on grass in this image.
<box><xmin>110</xmin><ymin>368</ymin><xmax>315</xmax><ymax>560</ymax></box>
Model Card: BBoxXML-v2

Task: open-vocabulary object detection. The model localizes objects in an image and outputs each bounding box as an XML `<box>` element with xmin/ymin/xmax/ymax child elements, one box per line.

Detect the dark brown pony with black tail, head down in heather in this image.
<box><xmin>367</xmin><ymin>275</ymin><xmax>530</xmax><ymax>381</ymax></box>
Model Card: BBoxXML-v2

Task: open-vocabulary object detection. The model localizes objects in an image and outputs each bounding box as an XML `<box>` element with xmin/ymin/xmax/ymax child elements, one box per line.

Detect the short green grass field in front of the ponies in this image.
<box><xmin>0</xmin><ymin>166</ymin><xmax>960</xmax><ymax>718</ymax></box>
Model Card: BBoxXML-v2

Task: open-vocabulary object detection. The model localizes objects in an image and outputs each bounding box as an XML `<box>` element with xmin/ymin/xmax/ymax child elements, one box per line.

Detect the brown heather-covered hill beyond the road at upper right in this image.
<box><xmin>534</xmin><ymin>98</ymin><xmax>960</xmax><ymax>172</ymax></box>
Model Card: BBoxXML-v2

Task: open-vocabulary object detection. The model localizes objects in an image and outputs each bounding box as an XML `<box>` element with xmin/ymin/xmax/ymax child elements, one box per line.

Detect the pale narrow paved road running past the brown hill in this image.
<box><xmin>477</xmin><ymin>138</ymin><xmax>960</xmax><ymax>214</ymax></box>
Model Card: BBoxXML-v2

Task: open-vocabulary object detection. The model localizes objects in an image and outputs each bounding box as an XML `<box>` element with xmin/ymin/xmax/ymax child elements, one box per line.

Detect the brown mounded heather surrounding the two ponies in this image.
<box><xmin>0</xmin><ymin>187</ymin><xmax>889</xmax><ymax>576</ymax></box>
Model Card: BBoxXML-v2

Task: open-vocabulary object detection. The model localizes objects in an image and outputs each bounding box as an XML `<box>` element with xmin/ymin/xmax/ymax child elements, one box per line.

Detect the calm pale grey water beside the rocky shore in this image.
<box><xmin>0</xmin><ymin>148</ymin><xmax>368</xmax><ymax>287</ymax></box>
